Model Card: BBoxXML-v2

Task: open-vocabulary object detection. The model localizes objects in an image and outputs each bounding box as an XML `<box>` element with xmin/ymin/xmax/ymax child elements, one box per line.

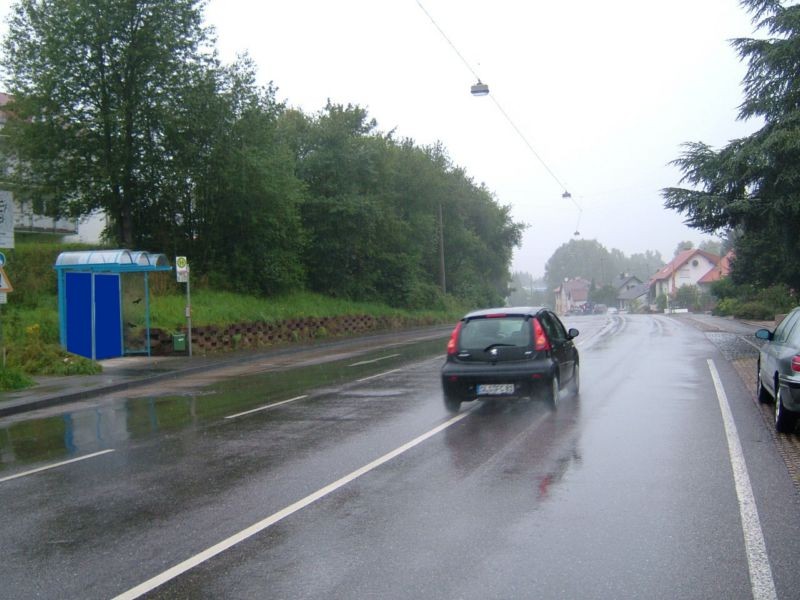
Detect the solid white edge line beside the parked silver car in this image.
<box><xmin>708</xmin><ymin>359</ymin><xmax>778</xmax><ymax>600</ymax></box>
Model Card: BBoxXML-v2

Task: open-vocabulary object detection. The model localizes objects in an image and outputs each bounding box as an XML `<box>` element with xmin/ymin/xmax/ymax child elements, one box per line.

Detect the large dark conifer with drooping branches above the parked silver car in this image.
<box><xmin>662</xmin><ymin>0</ymin><xmax>800</xmax><ymax>289</ymax></box>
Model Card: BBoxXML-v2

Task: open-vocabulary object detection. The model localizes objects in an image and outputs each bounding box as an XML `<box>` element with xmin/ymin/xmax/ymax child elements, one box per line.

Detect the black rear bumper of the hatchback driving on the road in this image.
<box><xmin>442</xmin><ymin>360</ymin><xmax>555</xmax><ymax>401</ymax></box>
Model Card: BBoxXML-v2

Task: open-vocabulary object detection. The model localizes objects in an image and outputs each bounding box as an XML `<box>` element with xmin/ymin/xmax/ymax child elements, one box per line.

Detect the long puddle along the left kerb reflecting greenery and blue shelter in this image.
<box><xmin>0</xmin><ymin>337</ymin><xmax>447</xmax><ymax>473</ymax></box>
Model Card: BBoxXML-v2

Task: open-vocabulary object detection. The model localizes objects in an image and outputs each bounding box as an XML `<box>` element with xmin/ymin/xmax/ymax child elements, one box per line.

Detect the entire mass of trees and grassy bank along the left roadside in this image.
<box><xmin>0</xmin><ymin>0</ymin><xmax>524</xmax><ymax>392</ymax></box>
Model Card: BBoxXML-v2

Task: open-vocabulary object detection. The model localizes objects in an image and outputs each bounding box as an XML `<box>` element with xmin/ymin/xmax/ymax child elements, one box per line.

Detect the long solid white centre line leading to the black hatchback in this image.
<box><xmin>113</xmin><ymin>409</ymin><xmax>474</xmax><ymax>600</ymax></box>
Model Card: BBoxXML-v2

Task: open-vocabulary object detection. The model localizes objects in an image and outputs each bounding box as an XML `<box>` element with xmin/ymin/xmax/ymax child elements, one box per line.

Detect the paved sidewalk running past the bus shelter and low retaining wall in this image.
<box><xmin>0</xmin><ymin>326</ymin><xmax>452</xmax><ymax>418</ymax></box>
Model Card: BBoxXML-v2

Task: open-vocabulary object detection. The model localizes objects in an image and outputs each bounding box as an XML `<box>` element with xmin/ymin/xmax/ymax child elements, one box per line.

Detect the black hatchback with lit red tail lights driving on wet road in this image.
<box><xmin>442</xmin><ymin>307</ymin><xmax>580</xmax><ymax>412</ymax></box>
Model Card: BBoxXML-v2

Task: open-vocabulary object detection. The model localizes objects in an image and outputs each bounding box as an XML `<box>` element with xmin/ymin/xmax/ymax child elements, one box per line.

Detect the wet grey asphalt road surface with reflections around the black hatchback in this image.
<box><xmin>0</xmin><ymin>315</ymin><xmax>800</xmax><ymax>599</ymax></box>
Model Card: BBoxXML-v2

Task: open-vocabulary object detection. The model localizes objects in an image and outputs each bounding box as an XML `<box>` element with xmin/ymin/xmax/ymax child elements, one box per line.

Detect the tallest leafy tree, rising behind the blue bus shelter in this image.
<box><xmin>2</xmin><ymin>0</ymin><xmax>215</xmax><ymax>247</ymax></box>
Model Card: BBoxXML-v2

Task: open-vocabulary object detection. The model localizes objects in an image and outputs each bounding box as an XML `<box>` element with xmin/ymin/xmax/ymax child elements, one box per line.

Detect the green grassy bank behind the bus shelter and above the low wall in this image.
<box><xmin>0</xmin><ymin>239</ymin><xmax>465</xmax><ymax>391</ymax></box>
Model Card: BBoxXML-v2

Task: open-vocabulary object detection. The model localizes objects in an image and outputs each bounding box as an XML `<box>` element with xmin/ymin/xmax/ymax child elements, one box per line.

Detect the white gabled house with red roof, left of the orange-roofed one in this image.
<box><xmin>650</xmin><ymin>248</ymin><xmax>731</xmax><ymax>298</ymax></box>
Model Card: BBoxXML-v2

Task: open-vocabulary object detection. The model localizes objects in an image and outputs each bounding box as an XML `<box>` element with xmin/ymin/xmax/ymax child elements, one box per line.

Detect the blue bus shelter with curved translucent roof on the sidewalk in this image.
<box><xmin>54</xmin><ymin>250</ymin><xmax>172</xmax><ymax>360</ymax></box>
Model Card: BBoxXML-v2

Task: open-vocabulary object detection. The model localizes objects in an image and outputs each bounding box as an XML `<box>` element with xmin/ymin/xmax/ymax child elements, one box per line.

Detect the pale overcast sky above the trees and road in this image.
<box><xmin>0</xmin><ymin>0</ymin><xmax>757</xmax><ymax>275</ymax></box>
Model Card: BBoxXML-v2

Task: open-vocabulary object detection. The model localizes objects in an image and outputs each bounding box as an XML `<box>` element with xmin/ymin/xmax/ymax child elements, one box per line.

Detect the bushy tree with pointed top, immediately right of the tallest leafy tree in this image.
<box><xmin>191</xmin><ymin>57</ymin><xmax>305</xmax><ymax>295</ymax></box>
